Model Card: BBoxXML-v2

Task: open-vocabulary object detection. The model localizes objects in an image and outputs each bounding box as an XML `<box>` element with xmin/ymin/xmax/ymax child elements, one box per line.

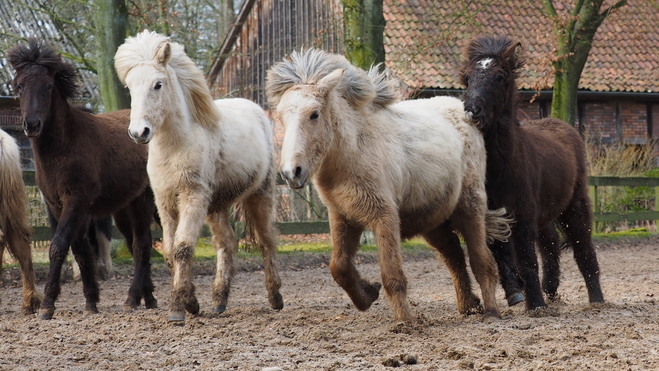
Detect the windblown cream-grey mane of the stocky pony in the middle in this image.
<box><xmin>265</xmin><ymin>49</ymin><xmax>401</xmax><ymax>108</ymax></box>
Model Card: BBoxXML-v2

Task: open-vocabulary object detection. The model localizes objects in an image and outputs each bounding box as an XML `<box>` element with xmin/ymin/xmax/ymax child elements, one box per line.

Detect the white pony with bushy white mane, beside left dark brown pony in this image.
<box><xmin>115</xmin><ymin>31</ymin><xmax>284</xmax><ymax>322</ymax></box>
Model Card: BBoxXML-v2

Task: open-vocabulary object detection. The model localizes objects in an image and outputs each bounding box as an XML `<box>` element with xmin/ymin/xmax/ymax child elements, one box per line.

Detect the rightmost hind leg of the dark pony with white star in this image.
<box><xmin>559</xmin><ymin>184</ymin><xmax>604</xmax><ymax>303</ymax></box>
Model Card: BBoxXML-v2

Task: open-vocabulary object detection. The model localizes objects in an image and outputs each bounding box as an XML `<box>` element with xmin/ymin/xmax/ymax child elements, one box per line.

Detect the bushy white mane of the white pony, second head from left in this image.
<box><xmin>114</xmin><ymin>30</ymin><xmax>220</xmax><ymax>128</ymax></box>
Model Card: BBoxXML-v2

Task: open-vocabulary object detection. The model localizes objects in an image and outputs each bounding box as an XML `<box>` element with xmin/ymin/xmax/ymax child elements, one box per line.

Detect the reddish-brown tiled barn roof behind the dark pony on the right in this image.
<box><xmin>384</xmin><ymin>0</ymin><xmax>659</xmax><ymax>92</ymax></box>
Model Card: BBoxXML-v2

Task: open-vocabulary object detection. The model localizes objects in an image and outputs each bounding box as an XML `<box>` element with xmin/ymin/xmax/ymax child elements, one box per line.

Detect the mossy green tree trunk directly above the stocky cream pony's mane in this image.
<box><xmin>341</xmin><ymin>0</ymin><xmax>385</xmax><ymax>69</ymax></box>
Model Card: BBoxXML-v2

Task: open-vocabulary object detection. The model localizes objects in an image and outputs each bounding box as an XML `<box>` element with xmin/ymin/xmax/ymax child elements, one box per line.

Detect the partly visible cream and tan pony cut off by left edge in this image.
<box><xmin>0</xmin><ymin>130</ymin><xmax>41</xmax><ymax>314</ymax></box>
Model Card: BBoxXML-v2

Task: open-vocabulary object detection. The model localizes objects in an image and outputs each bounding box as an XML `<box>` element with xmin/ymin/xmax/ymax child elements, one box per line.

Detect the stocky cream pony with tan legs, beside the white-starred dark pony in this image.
<box><xmin>266</xmin><ymin>49</ymin><xmax>509</xmax><ymax>320</ymax></box>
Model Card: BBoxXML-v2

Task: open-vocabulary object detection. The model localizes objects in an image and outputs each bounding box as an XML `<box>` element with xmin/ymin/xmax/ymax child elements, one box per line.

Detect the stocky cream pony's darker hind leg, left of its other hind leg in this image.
<box><xmin>423</xmin><ymin>222</ymin><xmax>482</xmax><ymax>314</ymax></box>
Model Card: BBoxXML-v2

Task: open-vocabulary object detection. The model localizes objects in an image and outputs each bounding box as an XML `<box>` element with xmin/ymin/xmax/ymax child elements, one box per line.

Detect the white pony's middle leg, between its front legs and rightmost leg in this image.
<box><xmin>206</xmin><ymin>209</ymin><xmax>238</xmax><ymax>313</ymax></box>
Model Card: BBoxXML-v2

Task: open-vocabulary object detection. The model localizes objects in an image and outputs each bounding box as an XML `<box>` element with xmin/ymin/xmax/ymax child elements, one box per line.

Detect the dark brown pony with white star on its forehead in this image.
<box><xmin>461</xmin><ymin>37</ymin><xmax>604</xmax><ymax>309</ymax></box>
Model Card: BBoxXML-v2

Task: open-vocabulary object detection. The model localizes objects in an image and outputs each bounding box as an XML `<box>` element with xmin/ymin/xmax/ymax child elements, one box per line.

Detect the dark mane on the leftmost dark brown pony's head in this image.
<box><xmin>7</xmin><ymin>37</ymin><xmax>78</xmax><ymax>99</ymax></box>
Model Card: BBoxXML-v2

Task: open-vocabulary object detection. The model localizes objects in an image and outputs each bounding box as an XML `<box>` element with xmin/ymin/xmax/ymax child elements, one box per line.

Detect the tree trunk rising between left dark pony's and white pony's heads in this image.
<box><xmin>96</xmin><ymin>0</ymin><xmax>130</xmax><ymax>112</ymax></box>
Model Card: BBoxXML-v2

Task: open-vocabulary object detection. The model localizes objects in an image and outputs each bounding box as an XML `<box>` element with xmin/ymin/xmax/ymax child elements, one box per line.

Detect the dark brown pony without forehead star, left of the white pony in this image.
<box><xmin>7</xmin><ymin>38</ymin><xmax>157</xmax><ymax>319</ymax></box>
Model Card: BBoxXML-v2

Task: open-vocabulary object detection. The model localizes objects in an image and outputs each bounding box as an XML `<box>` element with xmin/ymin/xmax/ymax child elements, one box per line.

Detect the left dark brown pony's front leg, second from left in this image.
<box><xmin>71</xmin><ymin>233</ymin><xmax>99</xmax><ymax>314</ymax></box>
